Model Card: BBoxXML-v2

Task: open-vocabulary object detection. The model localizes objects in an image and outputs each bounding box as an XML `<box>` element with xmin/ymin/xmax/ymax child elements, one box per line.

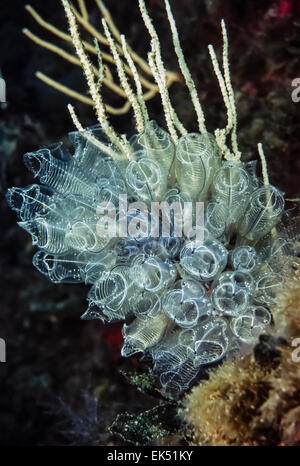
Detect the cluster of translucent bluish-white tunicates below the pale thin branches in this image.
<box><xmin>7</xmin><ymin>121</ymin><xmax>294</xmax><ymax>392</ymax></box>
